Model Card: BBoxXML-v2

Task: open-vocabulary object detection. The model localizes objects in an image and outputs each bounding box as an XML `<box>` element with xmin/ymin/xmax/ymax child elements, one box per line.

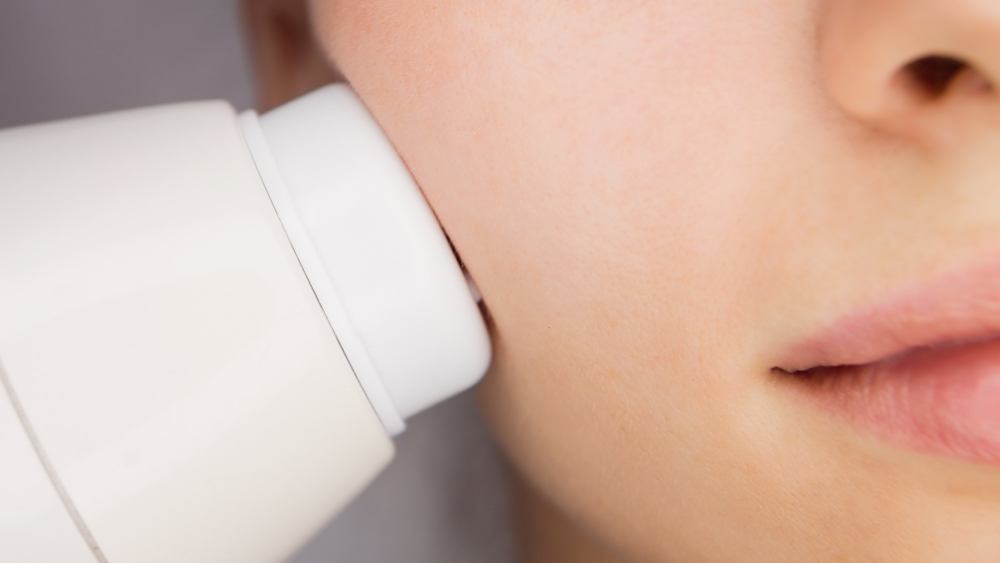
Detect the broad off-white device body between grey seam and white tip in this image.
<box><xmin>0</xmin><ymin>103</ymin><xmax>392</xmax><ymax>563</ymax></box>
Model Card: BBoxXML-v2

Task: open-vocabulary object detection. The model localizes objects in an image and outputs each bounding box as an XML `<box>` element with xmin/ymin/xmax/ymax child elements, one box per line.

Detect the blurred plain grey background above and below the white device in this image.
<box><xmin>0</xmin><ymin>0</ymin><xmax>514</xmax><ymax>563</ymax></box>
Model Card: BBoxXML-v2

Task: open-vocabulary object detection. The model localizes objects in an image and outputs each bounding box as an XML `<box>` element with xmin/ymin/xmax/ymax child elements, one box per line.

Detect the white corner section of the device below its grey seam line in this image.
<box><xmin>0</xmin><ymin>372</ymin><xmax>96</xmax><ymax>563</ymax></box>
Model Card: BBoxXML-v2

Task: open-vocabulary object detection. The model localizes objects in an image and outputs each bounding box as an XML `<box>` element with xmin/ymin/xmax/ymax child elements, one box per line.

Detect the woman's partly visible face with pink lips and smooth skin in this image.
<box><xmin>302</xmin><ymin>0</ymin><xmax>1000</xmax><ymax>562</ymax></box>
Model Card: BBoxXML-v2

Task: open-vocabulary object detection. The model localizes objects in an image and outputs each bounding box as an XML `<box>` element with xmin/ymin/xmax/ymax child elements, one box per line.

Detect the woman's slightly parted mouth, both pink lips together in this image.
<box><xmin>772</xmin><ymin>263</ymin><xmax>1000</xmax><ymax>464</ymax></box>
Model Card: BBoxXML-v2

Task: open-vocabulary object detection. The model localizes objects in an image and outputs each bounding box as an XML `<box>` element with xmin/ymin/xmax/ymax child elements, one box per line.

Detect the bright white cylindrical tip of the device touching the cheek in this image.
<box><xmin>242</xmin><ymin>85</ymin><xmax>490</xmax><ymax>434</ymax></box>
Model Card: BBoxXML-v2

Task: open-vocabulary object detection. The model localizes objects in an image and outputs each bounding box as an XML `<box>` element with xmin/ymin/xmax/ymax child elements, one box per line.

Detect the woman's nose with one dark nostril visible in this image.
<box><xmin>819</xmin><ymin>0</ymin><xmax>1000</xmax><ymax>142</ymax></box>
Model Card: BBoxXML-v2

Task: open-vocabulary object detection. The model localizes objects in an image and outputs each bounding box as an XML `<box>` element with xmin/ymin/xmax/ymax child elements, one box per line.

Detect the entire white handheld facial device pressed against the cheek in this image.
<box><xmin>0</xmin><ymin>86</ymin><xmax>490</xmax><ymax>563</ymax></box>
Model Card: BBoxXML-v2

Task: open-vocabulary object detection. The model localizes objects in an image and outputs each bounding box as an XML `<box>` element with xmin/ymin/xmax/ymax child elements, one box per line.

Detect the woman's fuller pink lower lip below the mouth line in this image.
<box><xmin>791</xmin><ymin>339</ymin><xmax>1000</xmax><ymax>463</ymax></box>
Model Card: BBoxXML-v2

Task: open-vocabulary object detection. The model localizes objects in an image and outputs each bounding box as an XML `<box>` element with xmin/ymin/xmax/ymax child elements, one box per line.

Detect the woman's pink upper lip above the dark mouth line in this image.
<box><xmin>775</xmin><ymin>261</ymin><xmax>1000</xmax><ymax>372</ymax></box>
